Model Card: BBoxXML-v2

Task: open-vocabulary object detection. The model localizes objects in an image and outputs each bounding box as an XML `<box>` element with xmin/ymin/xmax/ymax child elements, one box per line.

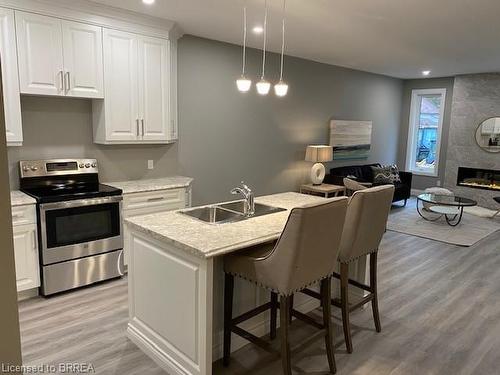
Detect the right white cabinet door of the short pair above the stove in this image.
<box><xmin>62</xmin><ymin>21</ymin><xmax>104</xmax><ymax>98</ymax></box>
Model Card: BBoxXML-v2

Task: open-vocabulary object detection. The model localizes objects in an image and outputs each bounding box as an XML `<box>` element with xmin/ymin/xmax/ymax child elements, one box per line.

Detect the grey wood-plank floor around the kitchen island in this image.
<box><xmin>20</xmin><ymin>232</ymin><xmax>500</xmax><ymax>375</ymax></box>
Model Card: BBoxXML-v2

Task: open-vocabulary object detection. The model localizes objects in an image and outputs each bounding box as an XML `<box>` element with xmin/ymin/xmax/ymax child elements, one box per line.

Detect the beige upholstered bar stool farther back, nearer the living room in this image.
<box><xmin>303</xmin><ymin>185</ymin><xmax>394</xmax><ymax>353</ymax></box>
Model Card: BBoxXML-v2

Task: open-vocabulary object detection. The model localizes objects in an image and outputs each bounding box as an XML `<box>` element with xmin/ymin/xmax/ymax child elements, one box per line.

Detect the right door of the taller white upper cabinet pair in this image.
<box><xmin>139</xmin><ymin>37</ymin><xmax>170</xmax><ymax>141</ymax></box>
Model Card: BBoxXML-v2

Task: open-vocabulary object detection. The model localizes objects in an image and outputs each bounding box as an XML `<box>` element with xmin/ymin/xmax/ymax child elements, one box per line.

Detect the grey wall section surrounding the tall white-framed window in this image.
<box><xmin>398</xmin><ymin>77</ymin><xmax>454</xmax><ymax>190</ymax></box>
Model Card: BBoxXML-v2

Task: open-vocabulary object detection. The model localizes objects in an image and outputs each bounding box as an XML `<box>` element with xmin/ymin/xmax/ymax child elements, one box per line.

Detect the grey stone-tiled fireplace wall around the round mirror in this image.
<box><xmin>445</xmin><ymin>73</ymin><xmax>500</xmax><ymax>209</ymax></box>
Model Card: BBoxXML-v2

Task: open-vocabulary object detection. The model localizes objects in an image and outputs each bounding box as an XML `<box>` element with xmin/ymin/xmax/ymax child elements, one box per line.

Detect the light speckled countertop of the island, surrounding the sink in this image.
<box><xmin>125</xmin><ymin>192</ymin><xmax>332</xmax><ymax>258</ymax></box>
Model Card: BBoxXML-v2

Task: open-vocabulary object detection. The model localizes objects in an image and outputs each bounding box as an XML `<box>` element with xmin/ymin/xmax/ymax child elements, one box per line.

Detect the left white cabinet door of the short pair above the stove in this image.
<box><xmin>15</xmin><ymin>12</ymin><xmax>64</xmax><ymax>95</ymax></box>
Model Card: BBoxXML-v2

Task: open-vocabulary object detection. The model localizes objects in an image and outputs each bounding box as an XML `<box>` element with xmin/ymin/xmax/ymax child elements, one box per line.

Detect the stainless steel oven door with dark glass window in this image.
<box><xmin>40</xmin><ymin>196</ymin><xmax>123</xmax><ymax>265</ymax></box>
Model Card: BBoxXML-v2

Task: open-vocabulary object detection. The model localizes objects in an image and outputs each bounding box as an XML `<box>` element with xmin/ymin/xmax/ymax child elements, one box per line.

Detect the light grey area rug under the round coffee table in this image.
<box><xmin>387</xmin><ymin>198</ymin><xmax>500</xmax><ymax>246</ymax></box>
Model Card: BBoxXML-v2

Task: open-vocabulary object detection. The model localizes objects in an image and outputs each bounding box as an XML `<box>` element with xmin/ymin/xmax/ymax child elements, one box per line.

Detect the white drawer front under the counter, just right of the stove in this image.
<box><xmin>123</xmin><ymin>189</ymin><xmax>186</xmax><ymax>216</ymax></box>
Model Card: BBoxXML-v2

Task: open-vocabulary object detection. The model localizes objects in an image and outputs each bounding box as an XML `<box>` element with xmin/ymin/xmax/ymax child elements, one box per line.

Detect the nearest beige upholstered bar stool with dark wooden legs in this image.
<box><xmin>223</xmin><ymin>197</ymin><xmax>347</xmax><ymax>375</ymax></box>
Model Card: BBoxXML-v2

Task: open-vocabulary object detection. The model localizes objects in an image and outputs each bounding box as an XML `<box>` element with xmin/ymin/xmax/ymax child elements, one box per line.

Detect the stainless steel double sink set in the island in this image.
<box><xmin>179</xmin><ymin>200</ymin><xmax>286</xmax><ymax>224</ymax></box>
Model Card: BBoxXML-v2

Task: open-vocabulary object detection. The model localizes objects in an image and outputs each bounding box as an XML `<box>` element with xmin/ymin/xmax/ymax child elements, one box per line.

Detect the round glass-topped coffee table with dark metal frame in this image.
<box><xmin>417</xmin><ymin>193</ymin><xmax>477</xmax><ymax>227</ymax></box>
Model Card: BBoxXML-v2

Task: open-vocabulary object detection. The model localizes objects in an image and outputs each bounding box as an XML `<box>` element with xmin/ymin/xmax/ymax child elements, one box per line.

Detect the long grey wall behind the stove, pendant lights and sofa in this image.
<box><xmin>5</xmin><ymin>36</ymin><xmax>403</xmax><ymax>204</ymax></box>
